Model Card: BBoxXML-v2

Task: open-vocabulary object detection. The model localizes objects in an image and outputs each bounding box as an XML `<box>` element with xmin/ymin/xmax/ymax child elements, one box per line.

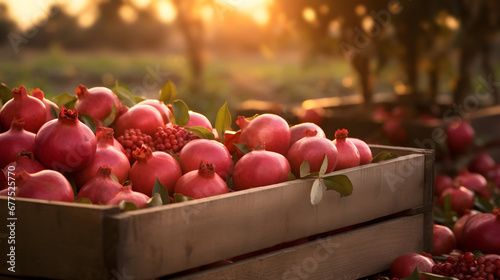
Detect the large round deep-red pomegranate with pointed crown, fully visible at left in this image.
<box><xmin>35</xmin><ymin>106</ymin><xmax>96</xmax><ymax>173</ymax></box>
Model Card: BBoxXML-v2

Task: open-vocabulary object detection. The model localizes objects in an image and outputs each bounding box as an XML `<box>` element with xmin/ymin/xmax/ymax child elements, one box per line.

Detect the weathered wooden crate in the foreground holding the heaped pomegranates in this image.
<box><xmin>0</xmin><ymin>146</ymin><xmax>434</xmax><ymax>279</ymax></box>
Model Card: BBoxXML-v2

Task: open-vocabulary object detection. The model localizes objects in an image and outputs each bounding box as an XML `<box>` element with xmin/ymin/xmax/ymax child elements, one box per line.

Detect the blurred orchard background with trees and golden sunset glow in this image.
<box><xmin>0</xmin><ymin>0</ymin><xmax>500</xmax><ymax>120</ymax></box>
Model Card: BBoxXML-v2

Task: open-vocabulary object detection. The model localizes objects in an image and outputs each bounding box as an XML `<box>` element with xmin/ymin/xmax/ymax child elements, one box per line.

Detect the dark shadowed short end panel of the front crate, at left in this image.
<box><xmin>0</xmin><ymin>197</ymin><xmax>119</xmax><ymax>279</ymax></box>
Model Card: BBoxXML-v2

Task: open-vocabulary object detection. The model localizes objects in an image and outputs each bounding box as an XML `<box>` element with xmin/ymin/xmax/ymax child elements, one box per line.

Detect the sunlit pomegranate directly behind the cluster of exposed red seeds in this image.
<box><xmin>115</xmin><ymin>104</ymin><xmax>165</xmax><ymax>137</ymax></box>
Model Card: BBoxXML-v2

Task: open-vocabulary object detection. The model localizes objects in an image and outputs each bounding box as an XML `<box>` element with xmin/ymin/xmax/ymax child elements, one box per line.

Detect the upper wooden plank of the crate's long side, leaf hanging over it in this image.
<box><xmin>109</xmin><ymin>150</ymin><xmax>426</xmax><ymax>278</ymax></box>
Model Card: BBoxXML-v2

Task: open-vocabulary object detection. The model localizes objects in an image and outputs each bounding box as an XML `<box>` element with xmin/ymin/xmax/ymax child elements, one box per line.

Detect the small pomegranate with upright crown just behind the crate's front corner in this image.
<box><xmin>77</xmin><ymin>165</ymin><xmax>122</xmax><ymax>204</ymax></box>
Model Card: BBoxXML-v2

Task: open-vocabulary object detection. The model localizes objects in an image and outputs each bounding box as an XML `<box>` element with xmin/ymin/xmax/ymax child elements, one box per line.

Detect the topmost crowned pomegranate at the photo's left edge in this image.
<box><xmin>0</xmin><ymin>85</ymin><xmax>46</xmax><ymax>133</ymax></box>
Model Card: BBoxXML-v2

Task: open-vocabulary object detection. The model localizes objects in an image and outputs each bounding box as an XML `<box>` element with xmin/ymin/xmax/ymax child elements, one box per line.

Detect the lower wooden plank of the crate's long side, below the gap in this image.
<box><xmin>171</xmin><ymin>214</ymin><xmax>425</xmax><ymax>280</ymax></box>
